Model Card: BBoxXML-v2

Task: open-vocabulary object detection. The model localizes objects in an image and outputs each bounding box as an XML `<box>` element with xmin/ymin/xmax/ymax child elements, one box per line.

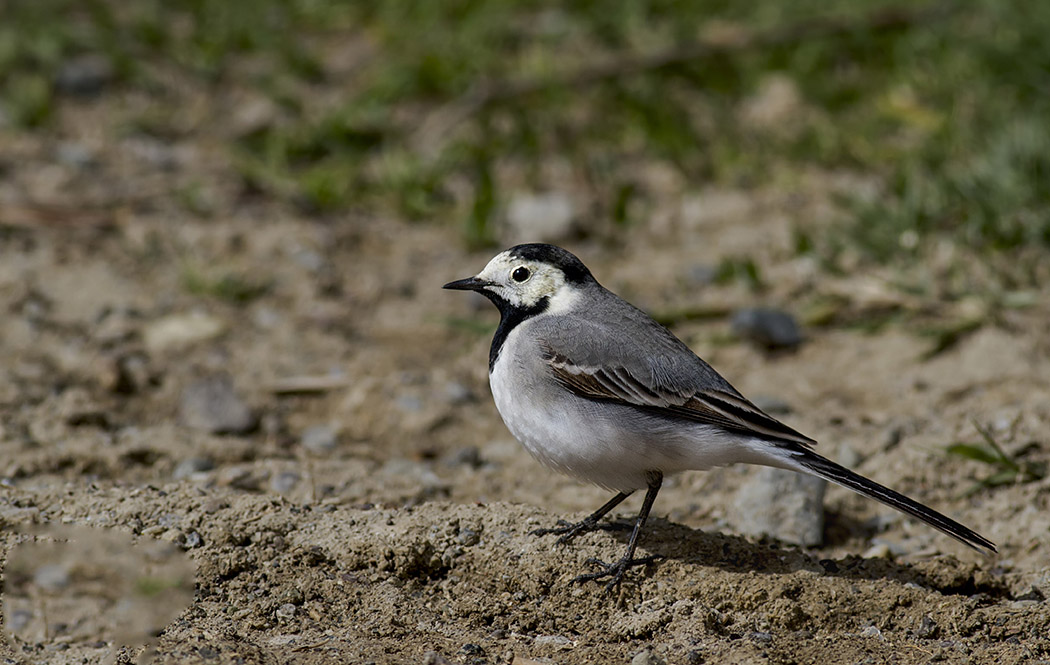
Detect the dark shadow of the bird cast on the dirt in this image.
<box><xmin>546</xmin><ymin>510</ymin><xmax>1009</xmax><ymax>598</ymax></box>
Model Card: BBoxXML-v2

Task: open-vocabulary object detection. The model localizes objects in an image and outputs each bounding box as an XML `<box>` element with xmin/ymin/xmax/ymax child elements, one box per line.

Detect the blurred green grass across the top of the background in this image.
<box><xmin>0</xmin><ymin>0</ymin><xmax>1050</xmax><ymax>273</ymax></box>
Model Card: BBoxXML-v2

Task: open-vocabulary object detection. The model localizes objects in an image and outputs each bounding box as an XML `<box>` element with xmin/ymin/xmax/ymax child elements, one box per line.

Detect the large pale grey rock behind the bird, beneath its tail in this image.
<box><xmin>730</xmin><ymin>467</ymin><xmax>827</xmax><ymax>546</ymax></box>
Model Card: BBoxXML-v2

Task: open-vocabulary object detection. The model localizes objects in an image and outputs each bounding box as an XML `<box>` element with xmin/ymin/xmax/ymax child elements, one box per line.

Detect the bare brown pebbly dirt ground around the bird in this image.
<box><xmin>0</xmin><ymin>80</ymin><xmax>1050</xmax><ymax>664</ymax></box>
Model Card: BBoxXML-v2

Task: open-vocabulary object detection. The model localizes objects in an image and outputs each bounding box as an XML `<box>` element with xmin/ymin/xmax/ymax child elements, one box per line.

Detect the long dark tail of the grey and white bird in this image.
<box><xmin>792</xmin><ymin>450</ymin><xmax>999</xmax><ymax>552</ymax></box>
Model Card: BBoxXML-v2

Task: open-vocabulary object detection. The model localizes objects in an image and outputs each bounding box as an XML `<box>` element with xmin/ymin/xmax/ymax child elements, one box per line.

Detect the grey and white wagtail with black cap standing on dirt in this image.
<box><xmin>444</xmin><ymin>244</ymin><xmax>995</xmax><ymax>590</ymax></box>
